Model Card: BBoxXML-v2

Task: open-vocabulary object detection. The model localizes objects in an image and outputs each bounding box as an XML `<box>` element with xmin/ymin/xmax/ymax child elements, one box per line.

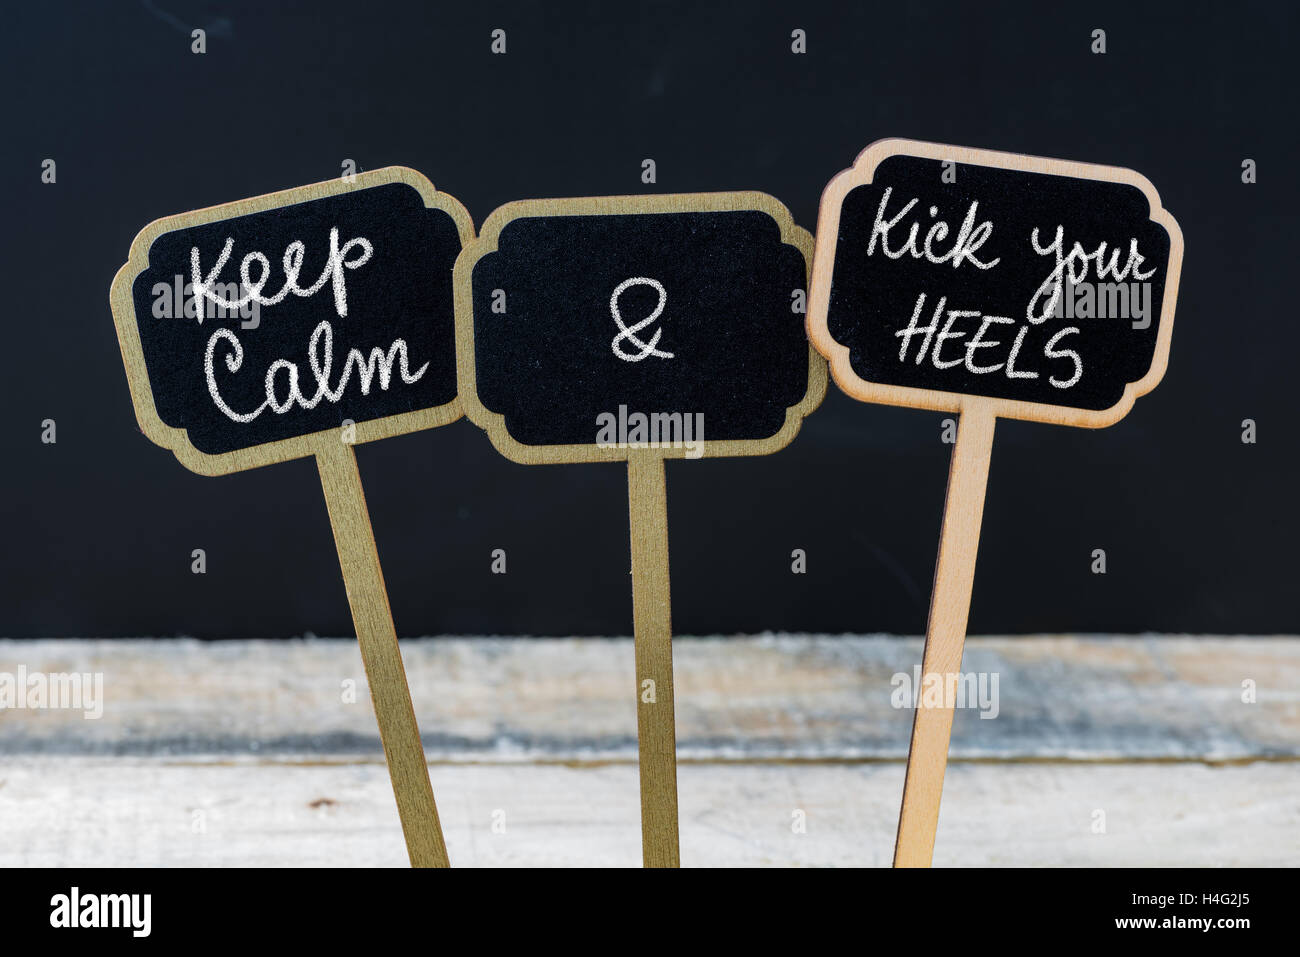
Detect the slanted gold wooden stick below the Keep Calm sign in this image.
<box><xmin>316</xmin><ymin>442</ymin><xmax>449</xmax><ymax>867</ymax></box>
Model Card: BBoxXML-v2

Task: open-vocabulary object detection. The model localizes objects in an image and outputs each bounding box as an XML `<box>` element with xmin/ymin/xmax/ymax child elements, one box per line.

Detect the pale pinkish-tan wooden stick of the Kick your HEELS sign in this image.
<box><xmin>894</xmin><ymin>404</ymin><xmax>997</xmax><ymax>867</ymax></box>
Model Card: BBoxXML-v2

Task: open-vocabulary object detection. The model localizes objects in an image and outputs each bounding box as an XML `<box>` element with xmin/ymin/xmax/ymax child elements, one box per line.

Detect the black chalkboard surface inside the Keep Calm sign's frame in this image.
<box><xmin>131</xmin><ymin>183</ymin><xmax>460</xmax><ymax>454</ymax></box>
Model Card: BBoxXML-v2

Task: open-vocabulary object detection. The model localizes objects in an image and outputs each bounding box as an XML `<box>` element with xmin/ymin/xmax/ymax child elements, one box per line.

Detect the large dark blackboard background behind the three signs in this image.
<box><xmin>0</xmin><ymin>0</ymin><xmax>1300</xmax><ymax>637</ymax></box>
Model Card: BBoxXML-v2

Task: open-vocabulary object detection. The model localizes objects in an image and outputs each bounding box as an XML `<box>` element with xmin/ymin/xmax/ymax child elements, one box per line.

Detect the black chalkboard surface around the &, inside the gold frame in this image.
<box><xmin>473</xmin><ymin>211</ymin><xmax>809</xmax><ymax>444</ymax></box>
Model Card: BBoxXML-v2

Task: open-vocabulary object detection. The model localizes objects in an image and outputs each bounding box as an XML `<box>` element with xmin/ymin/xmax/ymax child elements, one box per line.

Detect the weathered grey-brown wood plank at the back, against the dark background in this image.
<box><xmin>0</xmin><ymin>636</ymin><xmax>1300</xmax><ymax>762</ymax></box>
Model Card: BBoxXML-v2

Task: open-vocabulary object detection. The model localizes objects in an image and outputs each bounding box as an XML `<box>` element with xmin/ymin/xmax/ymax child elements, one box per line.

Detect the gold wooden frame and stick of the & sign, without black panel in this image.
<box><xmin>455</xmin><ymin>191</ymin><xmax>827</xmax><ymax>867</ymax></box>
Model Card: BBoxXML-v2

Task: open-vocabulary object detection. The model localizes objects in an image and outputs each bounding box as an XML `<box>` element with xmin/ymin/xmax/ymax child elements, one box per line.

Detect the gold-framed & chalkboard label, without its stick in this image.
<box><xmin>456</xmin><ymin>192</ymin><xmax>826</xmax><ymax>462</ymax></box>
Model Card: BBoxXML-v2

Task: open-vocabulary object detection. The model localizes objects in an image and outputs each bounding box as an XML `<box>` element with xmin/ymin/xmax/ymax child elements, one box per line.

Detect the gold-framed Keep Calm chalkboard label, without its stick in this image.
<box><xmin>114</xmin><ymin>168</ymin><xmax>472</xmax><ymax>471</ymax></box>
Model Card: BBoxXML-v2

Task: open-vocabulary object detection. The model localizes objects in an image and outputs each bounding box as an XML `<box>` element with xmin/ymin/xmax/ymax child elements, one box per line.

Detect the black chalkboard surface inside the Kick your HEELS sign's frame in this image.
<box><xmin>827</xmin><ymin>156</ymin><xmax>1170</xmax><ymax>410</ymax></box>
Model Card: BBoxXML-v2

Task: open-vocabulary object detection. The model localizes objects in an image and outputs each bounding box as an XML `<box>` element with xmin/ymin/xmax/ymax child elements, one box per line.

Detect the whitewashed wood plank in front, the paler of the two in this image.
<box><xmin>0</xmin><ymin>757</ymin><xmax>1300</xmax><ymax>867</ymax></box>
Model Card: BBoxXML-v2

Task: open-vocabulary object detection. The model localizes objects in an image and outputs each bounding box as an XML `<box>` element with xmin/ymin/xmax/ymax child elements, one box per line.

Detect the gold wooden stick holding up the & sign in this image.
<box><xmin>628</xmin><ymin>452</ymin><xmax>680</xmax><ymax>867</ymax></box>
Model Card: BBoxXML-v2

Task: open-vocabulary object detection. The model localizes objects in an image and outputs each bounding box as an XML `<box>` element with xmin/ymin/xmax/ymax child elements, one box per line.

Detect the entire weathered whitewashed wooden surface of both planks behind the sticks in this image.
<box><xmin>0</xmin><ymin>636</ymin><xmax>1300</xmax><ymax>867</ymax></box>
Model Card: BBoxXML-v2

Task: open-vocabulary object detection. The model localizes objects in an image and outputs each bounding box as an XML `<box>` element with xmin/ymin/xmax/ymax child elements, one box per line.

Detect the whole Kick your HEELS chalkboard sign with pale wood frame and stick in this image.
<box><xmin>807</xmin><ymin>139</ymin><xmax>1183</xmax><ymax>866</ymax></box>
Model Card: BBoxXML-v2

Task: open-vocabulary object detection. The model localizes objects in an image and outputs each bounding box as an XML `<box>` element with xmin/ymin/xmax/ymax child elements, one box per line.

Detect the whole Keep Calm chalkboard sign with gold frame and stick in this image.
<box><xmin>111</xmin><ymin>166</ymin><xmax>473</xmax><ymax>866</ymax></box>
